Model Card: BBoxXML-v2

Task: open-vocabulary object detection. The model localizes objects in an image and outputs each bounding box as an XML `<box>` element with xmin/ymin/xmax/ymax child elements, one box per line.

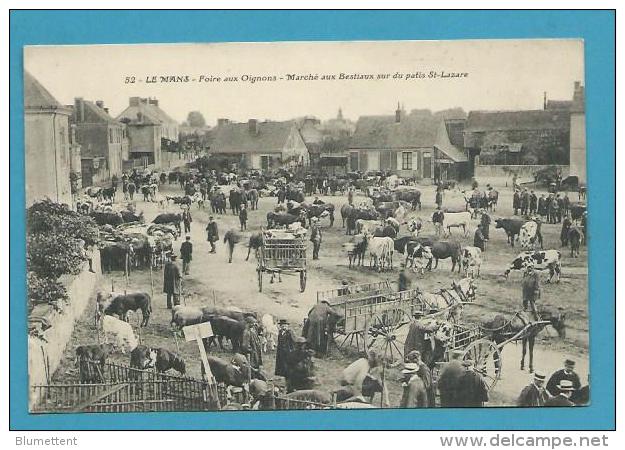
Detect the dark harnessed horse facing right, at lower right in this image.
<box><xmin>481</xmin><ymin>308</ymin><xmax>566</xmax><ymax>373</ymax></box>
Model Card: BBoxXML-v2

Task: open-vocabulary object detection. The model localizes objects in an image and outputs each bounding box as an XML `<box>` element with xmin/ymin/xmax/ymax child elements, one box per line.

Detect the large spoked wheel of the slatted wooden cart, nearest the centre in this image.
<box><xmin>367</xmin><ymin>309</ymin><xmax>410</xmax><ymax>366</ymax></box>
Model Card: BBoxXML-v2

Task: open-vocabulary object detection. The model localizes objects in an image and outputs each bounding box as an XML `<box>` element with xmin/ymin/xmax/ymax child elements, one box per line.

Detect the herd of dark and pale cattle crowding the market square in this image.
<box><xmin>66</xmin><ymin>165</ymin><xmax>586</xmax><ymax>412</ymax></box>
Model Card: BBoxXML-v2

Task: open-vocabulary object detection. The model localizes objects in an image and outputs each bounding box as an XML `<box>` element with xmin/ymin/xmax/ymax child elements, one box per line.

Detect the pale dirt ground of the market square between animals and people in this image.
<box><xmin>55</xmin><ymin>180</ymin><xmax>589</xmax><ymax>406</ymax></box>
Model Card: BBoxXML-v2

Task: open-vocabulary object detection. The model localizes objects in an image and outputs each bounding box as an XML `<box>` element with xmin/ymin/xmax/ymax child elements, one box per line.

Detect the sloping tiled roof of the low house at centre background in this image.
<box><xmin>211</xmin><ymin>121</ymin><xmax>294</xmax><ymax>153</ymax></box>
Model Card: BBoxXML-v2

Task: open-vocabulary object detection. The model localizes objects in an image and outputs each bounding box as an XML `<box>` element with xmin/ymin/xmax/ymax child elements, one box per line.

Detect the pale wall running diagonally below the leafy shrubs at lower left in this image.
<box><xmin>28</xmin><ymin>251</ymin><xmax>101</xmax><ymax>409</ymax></box>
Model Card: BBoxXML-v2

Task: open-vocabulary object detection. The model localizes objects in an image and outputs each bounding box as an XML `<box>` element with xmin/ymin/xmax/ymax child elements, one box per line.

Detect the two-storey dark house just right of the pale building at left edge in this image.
<box><xmin>71</xmin><ymin>98</ymin><xmax>129</xmax><ymax>186</ymax></box>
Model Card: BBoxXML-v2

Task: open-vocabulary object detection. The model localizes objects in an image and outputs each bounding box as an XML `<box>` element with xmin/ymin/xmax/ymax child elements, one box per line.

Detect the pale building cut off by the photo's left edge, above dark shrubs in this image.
<box><xmin>24</xmin><ymin>71</ymin><xmax>76</xmax><ymax>205</ymax></box>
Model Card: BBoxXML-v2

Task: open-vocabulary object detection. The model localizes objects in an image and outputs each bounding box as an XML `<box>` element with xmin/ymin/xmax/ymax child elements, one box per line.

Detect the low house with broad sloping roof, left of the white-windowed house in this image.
<box><xmin>210</xmin><ymin>119</ymin><xmax>310</xmax><ymax>171</ymax></box>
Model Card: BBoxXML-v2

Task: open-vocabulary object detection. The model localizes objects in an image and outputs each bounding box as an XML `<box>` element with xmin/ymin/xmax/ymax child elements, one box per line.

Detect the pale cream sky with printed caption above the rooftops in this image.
<box><xmin>24</xmin><ymin>40</ymin><xmax>584</xmax><ymax>125</ymax></box>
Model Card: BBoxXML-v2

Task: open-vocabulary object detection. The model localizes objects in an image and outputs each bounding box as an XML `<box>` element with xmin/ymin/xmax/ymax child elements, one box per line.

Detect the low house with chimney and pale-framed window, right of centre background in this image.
<box><xmin>349</xmin><ymin>105</ymin><xmax>468</xmax><ymax>181</ymax></box>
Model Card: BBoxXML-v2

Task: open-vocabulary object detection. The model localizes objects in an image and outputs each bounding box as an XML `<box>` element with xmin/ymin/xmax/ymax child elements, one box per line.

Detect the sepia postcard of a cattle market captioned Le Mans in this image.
<box><xmin>20</xmin><ymin>39</ymin><xmax>588</xmax><ymax>414</ymax></box>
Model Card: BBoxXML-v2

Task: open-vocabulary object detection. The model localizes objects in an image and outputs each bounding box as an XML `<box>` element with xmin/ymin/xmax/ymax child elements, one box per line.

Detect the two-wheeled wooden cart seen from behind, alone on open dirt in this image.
<box><xmin>256</xmin><ymin>230</ymin><xmax>306</xmax><ymax>292</ymax></box>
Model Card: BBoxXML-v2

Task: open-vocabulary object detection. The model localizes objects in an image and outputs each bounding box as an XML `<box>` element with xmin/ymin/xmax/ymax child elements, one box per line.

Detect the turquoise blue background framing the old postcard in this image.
<box><xmin>10</xmin><ymin>11</ymin><xmax>615</xmax><ymax>430</ymax></box>
